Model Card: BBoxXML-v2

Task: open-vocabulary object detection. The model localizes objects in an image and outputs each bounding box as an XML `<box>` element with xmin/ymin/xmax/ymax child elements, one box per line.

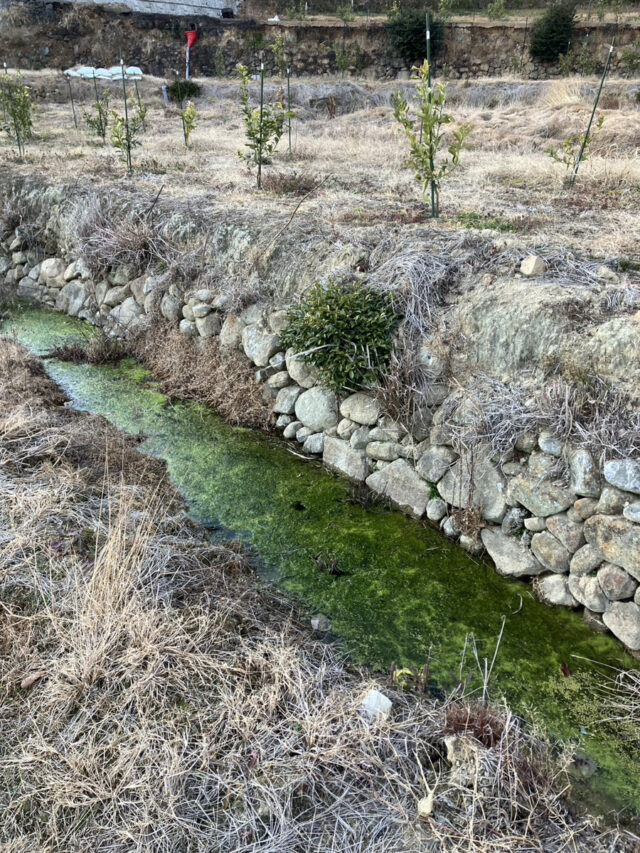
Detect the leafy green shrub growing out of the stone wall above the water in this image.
<box><xmin>282</xmin><ymin>280</ymin><xmax>400</xmax><ymax>391</ymax></box>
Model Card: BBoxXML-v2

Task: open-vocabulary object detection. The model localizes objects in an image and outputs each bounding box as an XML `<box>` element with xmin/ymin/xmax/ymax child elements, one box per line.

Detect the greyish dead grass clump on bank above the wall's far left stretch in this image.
<box><xmin>72</xmin><ymin>192</ymin><xmax>175</xmax><ymax>275</ymax></box>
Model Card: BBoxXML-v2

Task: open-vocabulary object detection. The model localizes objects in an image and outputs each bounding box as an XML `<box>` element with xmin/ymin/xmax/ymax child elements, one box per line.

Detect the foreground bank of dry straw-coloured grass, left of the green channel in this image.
<box><xmin>0</xmin><ymin>341</ymin><xmax>632</xmax><ymax>853</ymax></box>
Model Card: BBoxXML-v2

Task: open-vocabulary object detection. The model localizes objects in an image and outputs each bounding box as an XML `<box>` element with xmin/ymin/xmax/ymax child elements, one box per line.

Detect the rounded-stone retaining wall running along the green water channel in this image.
<box><xmin>0</xmin><ymin>226</ymin><xmax>640</xmax><ymax>653</ymax></box>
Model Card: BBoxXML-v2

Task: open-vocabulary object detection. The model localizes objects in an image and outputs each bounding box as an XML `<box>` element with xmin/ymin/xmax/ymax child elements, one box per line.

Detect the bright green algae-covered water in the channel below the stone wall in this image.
<box><xmin>4</xmin><ymin>308</ymin><xmax>640</xmax><ymax>812</ymax></box>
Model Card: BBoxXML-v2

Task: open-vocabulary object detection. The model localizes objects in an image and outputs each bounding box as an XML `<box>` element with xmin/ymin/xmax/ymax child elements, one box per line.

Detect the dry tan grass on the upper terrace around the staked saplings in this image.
<box><xmin>2</xmin><ymin>72</ymin><xmax>640</xmax><ymax>256</ymax></box>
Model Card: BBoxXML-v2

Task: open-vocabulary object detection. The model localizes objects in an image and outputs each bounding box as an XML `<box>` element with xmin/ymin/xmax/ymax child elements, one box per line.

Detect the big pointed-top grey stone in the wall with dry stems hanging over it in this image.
<box><xmin>438</xmin><ymin>446</ymin><xmax>507</xmax><ymax>524</ymax></box>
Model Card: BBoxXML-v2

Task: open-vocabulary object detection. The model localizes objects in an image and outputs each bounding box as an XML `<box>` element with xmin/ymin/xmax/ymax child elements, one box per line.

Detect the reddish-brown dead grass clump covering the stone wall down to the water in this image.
<box><xmin>131</xmin><ymin>320</ymin><xmax>271</xmax><ymax>429</ymax></box>
